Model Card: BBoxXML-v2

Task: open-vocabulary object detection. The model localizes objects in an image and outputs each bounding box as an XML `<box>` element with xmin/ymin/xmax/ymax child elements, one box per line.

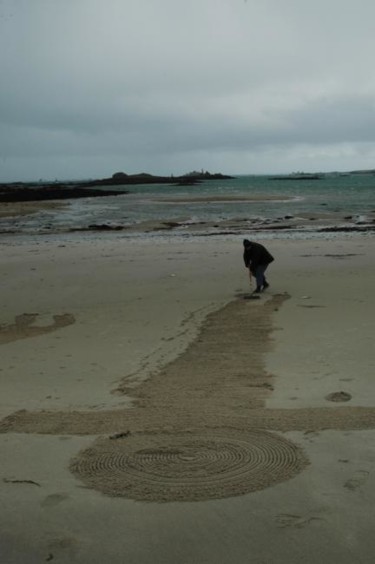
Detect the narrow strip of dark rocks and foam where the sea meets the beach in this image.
<box><xmin>0</xmin><ymin>212</ymin><xmax>375</xmax><ymax>241</ymax></box>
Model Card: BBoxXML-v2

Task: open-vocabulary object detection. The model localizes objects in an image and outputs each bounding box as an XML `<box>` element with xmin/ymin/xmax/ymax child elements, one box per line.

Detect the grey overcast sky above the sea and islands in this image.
<box><xmin>0</xmin><ymin>0</ymin><xmax>375</xmax><ymax>181</ymax></box>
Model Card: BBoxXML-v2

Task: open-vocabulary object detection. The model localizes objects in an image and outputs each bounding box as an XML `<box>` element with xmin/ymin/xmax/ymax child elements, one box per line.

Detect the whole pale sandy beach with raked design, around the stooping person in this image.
<box><xmin>0</xmin><ymin>233</ymin><xmax>375</xmax><ymax>564</ymax></box>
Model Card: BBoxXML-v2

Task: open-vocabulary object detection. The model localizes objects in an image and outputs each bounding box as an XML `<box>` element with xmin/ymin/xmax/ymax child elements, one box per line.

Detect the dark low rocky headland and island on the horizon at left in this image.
<box><xmin>0</xmin><ymin>171</ymin><xmax>233</xmax><ymax>202</ymax></box>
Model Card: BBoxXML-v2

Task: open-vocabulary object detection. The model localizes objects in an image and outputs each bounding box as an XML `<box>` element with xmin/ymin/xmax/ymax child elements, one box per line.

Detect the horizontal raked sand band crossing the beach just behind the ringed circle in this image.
<box><xmin>0</xmin><ymin>406</ymin><xmax>375</xmax><ymax>439</ymax></box>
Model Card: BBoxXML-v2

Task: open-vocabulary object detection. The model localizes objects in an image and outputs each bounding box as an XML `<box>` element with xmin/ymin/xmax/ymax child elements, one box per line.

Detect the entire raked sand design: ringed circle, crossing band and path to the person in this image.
<box><xmin>0</xmin><ymin>294</ymin><xmax>375</xmax><ymax>501</ymax></box>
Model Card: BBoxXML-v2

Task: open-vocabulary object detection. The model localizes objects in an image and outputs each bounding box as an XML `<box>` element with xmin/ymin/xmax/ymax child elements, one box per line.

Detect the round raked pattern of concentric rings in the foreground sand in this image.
<box><xmin>71</xmin><ymin>429</ymin><xmax>307</xmax><ymax>502</ymax></box>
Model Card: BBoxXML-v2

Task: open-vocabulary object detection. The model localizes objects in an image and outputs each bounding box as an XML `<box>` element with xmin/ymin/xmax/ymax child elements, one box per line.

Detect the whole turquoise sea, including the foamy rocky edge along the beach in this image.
<box><xmin>0</xmin><ymin>173</ymin><xmax>375</xmax><ymax>239</ymax></box>
